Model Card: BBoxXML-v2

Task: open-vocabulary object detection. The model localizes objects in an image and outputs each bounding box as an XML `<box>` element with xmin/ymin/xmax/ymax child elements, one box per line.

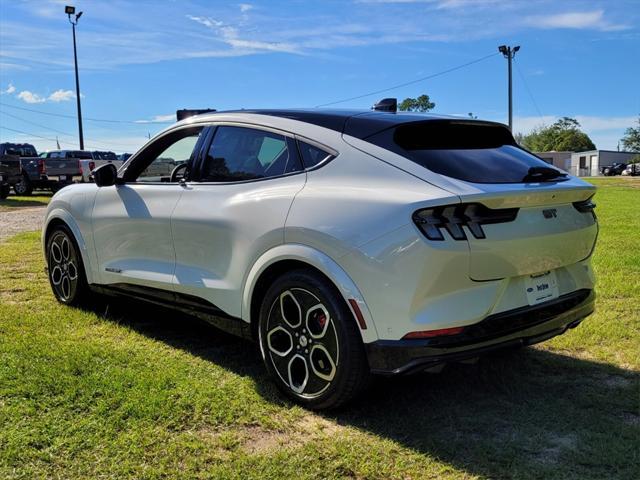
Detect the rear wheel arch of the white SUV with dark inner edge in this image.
<box><xmin>242</xmin><ymin>244</ymin><xmax>378</xmax><ymax>343</ymax></box>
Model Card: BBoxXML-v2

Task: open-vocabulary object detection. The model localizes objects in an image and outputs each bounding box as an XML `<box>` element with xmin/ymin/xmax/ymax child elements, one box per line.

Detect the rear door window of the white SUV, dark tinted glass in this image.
<box><xmin>200</xmin><ymin>126</ymin><xmax>302</xmax><ymax>182</ymax></box>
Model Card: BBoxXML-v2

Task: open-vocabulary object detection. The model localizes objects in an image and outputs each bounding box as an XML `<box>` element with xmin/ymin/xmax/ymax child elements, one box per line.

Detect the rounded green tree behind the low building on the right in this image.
<box><xmin>522</xmin><ymin>117</ymin><xmax>596</xmax><ymax>152</ymax></box>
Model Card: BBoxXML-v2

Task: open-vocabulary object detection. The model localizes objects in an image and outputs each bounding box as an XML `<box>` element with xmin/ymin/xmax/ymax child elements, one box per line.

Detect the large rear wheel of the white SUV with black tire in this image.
<box><xmin>258</xmin><ymin>270</ymin><xmax>370</xmax><ymax>410</ymax></box>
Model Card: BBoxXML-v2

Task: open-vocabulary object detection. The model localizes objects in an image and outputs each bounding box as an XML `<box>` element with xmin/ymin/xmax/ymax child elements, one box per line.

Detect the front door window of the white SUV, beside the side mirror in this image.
<box><xmin>125</xmin><ymin>127</ymin><xmax>202</xmax><ymax>183</ymax></box>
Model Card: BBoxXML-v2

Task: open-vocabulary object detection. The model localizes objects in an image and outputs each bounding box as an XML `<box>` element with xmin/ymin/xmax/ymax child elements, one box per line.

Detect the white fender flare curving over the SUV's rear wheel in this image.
<box><xmin>242</xmin><ymin>243</ymin><xmax>378</xmax><ymax>343</ymax></box>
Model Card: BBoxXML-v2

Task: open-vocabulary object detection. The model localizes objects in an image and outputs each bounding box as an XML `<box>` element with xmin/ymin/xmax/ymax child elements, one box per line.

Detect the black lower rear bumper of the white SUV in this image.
<box><xmin>365</xmin><ymin>289</ymin><xmax>595</xmax><ymax>375</ymax></box>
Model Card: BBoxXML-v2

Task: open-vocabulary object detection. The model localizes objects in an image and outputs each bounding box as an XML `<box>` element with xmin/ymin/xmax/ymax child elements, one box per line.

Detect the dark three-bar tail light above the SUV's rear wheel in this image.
<box><xmin>413</xmin><ymin>203</ymin><xmax>519</xmax><ymax>240</ymax></box>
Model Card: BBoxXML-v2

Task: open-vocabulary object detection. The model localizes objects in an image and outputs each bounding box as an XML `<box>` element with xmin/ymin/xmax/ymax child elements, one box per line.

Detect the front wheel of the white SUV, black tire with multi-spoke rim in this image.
<box><xmin>46</xmin><ymin>225</ymin><xmax>90</xmax><ymax>305</ymax></box>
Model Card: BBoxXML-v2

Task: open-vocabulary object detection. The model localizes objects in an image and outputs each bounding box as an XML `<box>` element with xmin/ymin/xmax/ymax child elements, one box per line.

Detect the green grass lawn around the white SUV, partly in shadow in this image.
<box><xmin>0</xmin><ymin>178</ymin><xmax>640</xmax><ymax>479</ymax></box>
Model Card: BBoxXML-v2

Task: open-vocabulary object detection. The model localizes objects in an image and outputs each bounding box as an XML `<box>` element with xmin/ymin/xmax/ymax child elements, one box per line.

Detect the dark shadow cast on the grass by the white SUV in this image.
<box><xmin>86</xmin><ymin>299</ymin><xmax>640</xmax><ymax>478</ymax></box>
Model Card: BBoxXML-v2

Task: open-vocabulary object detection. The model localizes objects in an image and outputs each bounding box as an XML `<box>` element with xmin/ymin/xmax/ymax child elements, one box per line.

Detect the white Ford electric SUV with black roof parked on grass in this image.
<box><xmin>42</xmin><ymin>110</ymin><xmax>598</xmax><ymax>409</ymax></box>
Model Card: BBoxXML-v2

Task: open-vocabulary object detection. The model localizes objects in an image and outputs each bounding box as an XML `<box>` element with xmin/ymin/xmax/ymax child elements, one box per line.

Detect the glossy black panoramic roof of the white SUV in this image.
<box><xmin>220</xmin><ymin>109</ymin><xmax>469</xmax><ymax>139</ymax></box>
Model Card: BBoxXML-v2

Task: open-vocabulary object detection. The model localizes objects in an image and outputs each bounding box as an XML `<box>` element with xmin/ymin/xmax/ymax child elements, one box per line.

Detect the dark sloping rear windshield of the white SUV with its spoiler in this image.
<box><xmin>366</xmin><ymin>120</ymin><xmax>562</xmax><ymax>183</ymax></box>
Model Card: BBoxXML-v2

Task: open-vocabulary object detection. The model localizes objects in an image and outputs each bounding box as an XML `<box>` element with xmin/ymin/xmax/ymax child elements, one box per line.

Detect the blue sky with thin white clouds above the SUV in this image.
<box><xmin>0</xmin><ymin>0</ymin><xmax>640</xmax><ymax>152</ymax></box>
